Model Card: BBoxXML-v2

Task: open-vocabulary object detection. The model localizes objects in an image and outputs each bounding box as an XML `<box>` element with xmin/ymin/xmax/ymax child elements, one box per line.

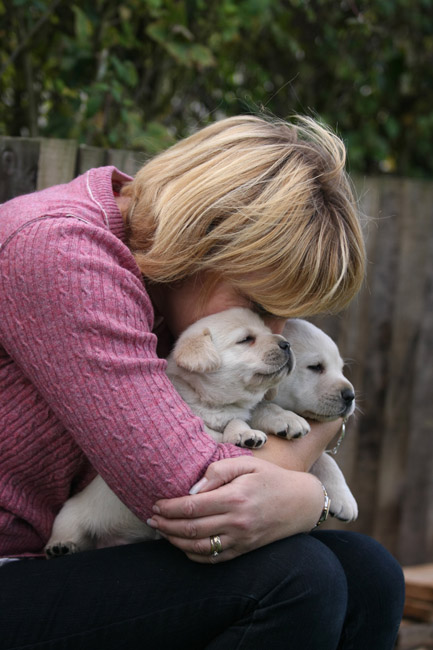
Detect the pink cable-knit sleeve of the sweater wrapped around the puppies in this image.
<box><xmin>0</xmin><ymin>217</ymin><xmax>250</xmax><ymax>518</ymax></box>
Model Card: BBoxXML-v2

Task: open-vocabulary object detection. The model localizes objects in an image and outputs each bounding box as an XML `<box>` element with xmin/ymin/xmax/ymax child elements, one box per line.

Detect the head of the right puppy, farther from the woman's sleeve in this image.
<box><xmin>275</xmin><ymin>318</ymin><xmax>355</xmax><ymax>421</ymax></box>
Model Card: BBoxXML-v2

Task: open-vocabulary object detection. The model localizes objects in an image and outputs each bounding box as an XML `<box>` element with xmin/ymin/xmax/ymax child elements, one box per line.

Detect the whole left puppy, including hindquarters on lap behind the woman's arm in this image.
<box><xmin>45</xmin><ymin>308</ymin><xmax>309</xmax><ymax>557</ymax></box>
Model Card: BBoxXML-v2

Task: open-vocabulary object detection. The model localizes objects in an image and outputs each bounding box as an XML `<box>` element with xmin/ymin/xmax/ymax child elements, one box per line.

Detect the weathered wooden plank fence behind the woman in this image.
<box><xmin>0</xmin><ymin>138</ymin><xmax>433</xmax><ymax>565</ymax></box>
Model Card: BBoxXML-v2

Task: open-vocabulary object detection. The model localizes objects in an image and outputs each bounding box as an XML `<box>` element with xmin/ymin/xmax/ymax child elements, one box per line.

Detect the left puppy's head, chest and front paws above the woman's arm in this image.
<box><xmin>167</xmin><ymin>308</ymin><xmax>309</xmax><ymax>447</ymax></box>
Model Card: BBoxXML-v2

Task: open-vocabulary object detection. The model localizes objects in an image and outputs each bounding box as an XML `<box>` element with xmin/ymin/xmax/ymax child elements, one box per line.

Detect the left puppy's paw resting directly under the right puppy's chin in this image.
<box><xmin>251</xmin><ymin>402</ymin><xmax>310</xmax><ymax>439</ymax></box>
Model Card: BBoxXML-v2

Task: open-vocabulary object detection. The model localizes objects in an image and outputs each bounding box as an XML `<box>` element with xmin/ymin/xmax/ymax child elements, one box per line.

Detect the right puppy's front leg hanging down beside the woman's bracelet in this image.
<box><xmin>310</xmin><ymin>454</ymin><xmax>358</xmax><ymax>521</ymax></box>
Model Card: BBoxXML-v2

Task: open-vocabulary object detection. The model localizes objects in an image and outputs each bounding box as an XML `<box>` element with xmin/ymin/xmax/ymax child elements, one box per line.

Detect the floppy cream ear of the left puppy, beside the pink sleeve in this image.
<box><xmin>173</xmin><ymin>328</ymin><xmax>221</xmax><ymax>373</ymax></box>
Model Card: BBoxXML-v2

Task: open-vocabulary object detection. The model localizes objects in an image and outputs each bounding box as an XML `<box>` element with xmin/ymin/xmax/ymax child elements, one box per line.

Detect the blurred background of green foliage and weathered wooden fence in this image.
<box><xmin>0</xmin><ymin>0</ymin><xmax>433</xmax><ymax>568</ymax></box>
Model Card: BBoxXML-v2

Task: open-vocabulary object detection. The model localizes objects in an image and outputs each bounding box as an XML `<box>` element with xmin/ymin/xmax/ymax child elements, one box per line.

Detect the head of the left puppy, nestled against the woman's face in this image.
<box><xmin>168</xmin><ymin>307</ymin><xmax>294</xmax><ymax>403</ymax></box>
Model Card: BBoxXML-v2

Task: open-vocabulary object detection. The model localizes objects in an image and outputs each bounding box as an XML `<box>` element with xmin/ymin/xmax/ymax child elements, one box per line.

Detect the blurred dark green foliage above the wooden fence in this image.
<box><xmin>0</xmin><ymin>0</ymin><xmax>433</xmax><ymax>177</ymax></box>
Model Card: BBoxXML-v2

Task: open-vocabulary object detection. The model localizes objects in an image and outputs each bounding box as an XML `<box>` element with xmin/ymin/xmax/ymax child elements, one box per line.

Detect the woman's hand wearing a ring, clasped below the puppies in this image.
<box><xmin>148</xmin><ymin>454</ymin><xmax>323</xmax><ymax>563</ymax></box>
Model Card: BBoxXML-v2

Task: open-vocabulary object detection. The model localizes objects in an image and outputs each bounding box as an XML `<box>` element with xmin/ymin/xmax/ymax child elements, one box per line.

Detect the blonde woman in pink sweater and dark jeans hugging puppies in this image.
<box><xmin>0</xmin><ymin>116</ymin><xmax>403</xmax><ymax>650</ymax></box>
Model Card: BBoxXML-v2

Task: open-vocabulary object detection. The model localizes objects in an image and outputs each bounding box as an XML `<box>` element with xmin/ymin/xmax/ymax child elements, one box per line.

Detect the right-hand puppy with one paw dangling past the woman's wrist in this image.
<box><xmin>254</xmin><ymin>318</ymin><xmax>358</xmax><ymax>521</ymax></box>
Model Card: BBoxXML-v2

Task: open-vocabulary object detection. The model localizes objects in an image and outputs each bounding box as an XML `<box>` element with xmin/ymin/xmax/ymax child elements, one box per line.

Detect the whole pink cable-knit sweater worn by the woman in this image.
<box><xmin>0</xmin><ymin>167</ymin><xmax>250</xmax><ymax>556</ymax></box>
